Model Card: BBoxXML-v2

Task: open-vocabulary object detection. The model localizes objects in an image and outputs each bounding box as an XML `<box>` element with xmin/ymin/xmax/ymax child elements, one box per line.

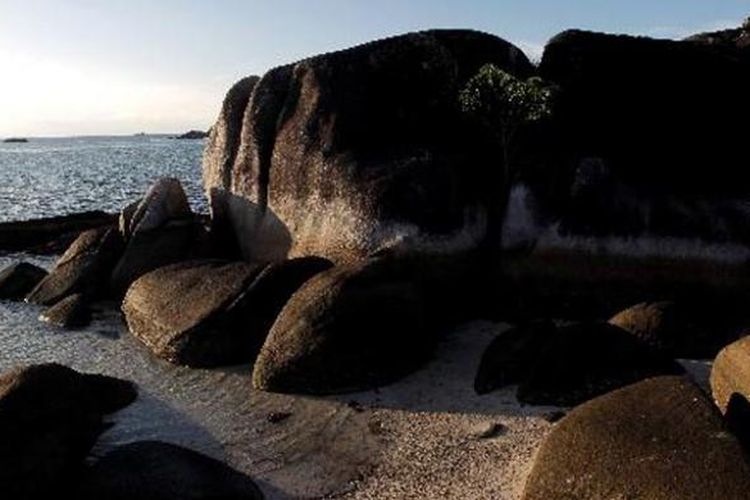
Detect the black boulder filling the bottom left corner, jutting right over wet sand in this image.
<box><xmin>0</xmin><ymin>364</ymin><xmax>136</xmax><ymax>499</ymax></box>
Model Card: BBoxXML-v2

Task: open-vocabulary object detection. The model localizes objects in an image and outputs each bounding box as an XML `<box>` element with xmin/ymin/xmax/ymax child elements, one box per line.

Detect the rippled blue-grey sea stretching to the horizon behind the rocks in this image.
<box><xmin>0</xmin><ymin>136</ymin><xmax>206</xmax><ymax>222</ymax></box>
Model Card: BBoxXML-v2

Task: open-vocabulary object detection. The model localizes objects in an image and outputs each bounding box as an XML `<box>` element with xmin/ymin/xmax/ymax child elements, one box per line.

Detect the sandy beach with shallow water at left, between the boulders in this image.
<box><xmin>0</xmin><ymin>254</ymin><xmax>554</xmax><ymax>499</ymax></box>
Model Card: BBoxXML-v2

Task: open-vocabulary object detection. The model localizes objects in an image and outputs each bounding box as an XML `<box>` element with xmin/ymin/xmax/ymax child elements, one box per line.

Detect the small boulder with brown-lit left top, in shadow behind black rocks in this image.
<box><xmin>609</xmin><ymin>301</ymin><xmax>736</xmax><ymax>359</ymax></box>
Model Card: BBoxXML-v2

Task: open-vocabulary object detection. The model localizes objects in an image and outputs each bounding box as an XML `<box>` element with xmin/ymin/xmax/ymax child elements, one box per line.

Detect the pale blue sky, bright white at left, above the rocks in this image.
<box><xmin>0</xmin><ymin>0</ymin><xmax>750</xmax><ymax>137</ymax></box>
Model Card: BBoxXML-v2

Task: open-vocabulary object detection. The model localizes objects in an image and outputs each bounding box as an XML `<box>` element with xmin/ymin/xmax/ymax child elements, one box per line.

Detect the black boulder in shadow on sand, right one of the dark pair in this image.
<box><xmin>518</xmin><ymin>323</ymin><xmax>684</xmax><ymax>406</ymax></box>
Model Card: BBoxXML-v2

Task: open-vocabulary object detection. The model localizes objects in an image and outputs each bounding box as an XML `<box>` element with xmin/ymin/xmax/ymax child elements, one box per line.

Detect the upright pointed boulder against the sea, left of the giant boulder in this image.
<box><xmin>111</xmin><ymin>178</ymin><xmax>203</xmax><ymax>297</ymax></box>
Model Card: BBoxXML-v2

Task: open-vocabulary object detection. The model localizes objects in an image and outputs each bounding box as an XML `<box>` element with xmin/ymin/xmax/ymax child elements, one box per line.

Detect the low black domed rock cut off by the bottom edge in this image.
<box><xmin>78</xmin><ymin>441</ymin><xmax>263</xmax><ymax>500</ymax></box>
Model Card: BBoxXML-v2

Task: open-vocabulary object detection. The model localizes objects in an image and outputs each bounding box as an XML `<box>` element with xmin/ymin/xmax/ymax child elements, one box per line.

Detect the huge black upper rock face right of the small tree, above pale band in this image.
<box><xmin>531</xmin><ymin>30</ymin><xmax>750</xmax><ymax>244</ymax></box>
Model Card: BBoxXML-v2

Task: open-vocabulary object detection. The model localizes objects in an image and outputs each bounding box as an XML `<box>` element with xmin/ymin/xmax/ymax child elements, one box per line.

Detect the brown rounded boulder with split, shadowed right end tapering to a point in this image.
<box><xmin>123</xmin><ymin>258</ymin><xmax>330</xmax><ymax>366</ymax></box>
